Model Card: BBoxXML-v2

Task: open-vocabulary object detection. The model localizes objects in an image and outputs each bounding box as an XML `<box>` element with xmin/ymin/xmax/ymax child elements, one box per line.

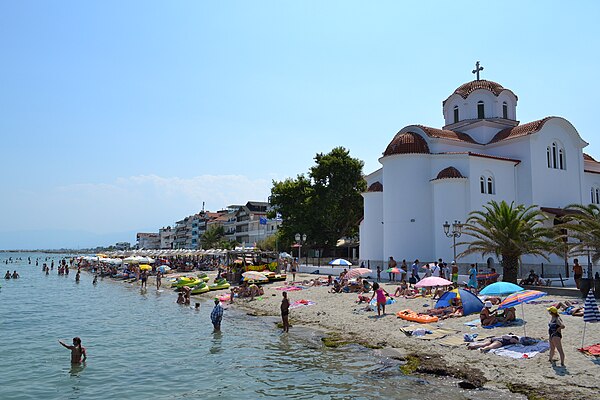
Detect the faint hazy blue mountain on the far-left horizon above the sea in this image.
<box><xmin>0</xmin><ymin>229</ymin><xmax>136</xmax><ymax>250</ymax></box>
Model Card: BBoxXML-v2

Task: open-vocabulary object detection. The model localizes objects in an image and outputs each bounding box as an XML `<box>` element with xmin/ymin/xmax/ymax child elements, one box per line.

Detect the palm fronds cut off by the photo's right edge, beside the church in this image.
<box><xmin>563</xmin><ymin>204</ymin><xmax>600</xmax><ymax>272</ymax></box>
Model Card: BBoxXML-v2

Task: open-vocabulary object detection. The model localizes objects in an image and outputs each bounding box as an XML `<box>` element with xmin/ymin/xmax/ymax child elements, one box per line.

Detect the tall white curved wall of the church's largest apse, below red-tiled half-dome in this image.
<box><xmin>381</xmin><ymin>154</ymin><xmax>433</xmax><ymax>260</ymax></box>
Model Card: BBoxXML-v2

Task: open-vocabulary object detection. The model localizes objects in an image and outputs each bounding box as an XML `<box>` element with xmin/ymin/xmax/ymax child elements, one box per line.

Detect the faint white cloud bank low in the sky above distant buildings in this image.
<box><xmin>0</xmin><ymin>175</ymin><xmax>271</xmax><ymax>233</ymax></box>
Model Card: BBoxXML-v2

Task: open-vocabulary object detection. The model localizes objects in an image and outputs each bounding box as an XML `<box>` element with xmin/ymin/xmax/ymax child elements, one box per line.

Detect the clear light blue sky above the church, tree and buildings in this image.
<box><xmin>0</xmin><ymin>0</ymin><xmax>600</xmax><ymax>249</ymax></box>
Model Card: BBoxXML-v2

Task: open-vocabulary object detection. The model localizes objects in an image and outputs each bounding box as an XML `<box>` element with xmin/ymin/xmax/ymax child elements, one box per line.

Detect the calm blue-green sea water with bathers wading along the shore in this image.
<box><xmin>0</xmin><ymin>253</ymin><xmax>520</xmax><ymax>400</ymax></box>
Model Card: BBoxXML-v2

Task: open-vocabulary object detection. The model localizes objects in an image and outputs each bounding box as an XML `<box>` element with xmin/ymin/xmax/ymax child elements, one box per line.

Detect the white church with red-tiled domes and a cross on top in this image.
<box><xmin>360</xmin><ymin>63</ymin><xmax>600</xmax><ymax>271</ymax></box>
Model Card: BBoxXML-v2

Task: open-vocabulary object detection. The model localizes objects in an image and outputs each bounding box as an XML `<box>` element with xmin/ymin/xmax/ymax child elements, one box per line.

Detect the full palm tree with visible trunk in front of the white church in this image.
<box><xmin>457</xmin><ymin>200</ymin><xmax>555</xmax><ymax>283</ymax></box>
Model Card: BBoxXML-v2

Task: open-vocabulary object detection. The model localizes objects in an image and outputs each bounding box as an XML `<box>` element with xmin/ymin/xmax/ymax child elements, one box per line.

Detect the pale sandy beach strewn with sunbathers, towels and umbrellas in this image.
<box><xmin>182</xmin><ymin>274</ymin><xmax>600</xmax><ymax>399</ymax></box>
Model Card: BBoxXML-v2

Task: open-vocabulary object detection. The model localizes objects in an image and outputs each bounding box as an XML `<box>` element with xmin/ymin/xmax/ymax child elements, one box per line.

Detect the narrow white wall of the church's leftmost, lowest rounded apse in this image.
<box><xmin>359</xmin><ymin>193</ymin><xmax>385</xmax><ymax>261</ymax></box>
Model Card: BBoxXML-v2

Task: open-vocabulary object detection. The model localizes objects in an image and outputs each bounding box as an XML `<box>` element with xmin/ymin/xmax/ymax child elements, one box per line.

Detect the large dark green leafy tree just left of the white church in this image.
<box><xmin>271</xmin><ymin>147</ymin><xmax>367</xmax><ymax>253</ymax></box>
